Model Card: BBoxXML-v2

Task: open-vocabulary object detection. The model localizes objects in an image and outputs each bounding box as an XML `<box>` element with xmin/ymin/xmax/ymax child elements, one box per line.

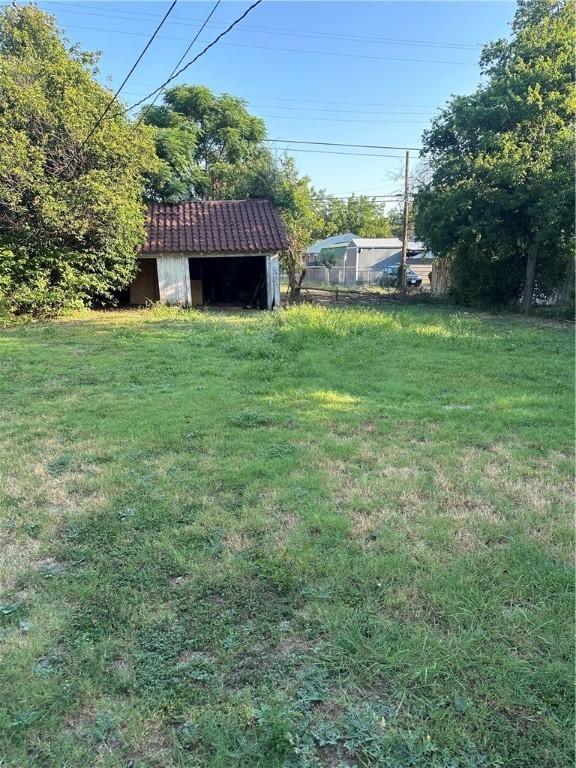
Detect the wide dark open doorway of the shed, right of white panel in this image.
<box><xmin>188</xmin><ymin>256</ymin><xmax>267</xmax><ymax>309</ymax></box>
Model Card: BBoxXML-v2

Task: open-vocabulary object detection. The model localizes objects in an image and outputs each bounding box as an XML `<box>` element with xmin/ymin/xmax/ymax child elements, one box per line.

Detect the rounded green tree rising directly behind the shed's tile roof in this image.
<box><xmin>141</xmin><ymin>85</ymin><xmax>269</xmax><ymax>202</ymax></box>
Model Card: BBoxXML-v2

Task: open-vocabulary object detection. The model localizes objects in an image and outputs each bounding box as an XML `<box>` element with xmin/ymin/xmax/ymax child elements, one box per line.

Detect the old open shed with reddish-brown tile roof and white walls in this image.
<box><xmin>128</xmin><ymin>200</ymin><xmax>288</xmax><ymax>309</ymax></box>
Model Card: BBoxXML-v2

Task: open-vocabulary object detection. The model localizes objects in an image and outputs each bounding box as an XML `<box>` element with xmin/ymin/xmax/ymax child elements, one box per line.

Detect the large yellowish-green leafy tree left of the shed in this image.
<box><xmin>0</xmin><ymin>6</ymin><xmax>157</xmax><ymax>313</ymax></box>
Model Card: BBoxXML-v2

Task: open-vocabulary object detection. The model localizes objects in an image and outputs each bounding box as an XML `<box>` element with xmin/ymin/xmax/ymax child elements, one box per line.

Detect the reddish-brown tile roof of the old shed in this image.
<box><xmin>142</xmin><ymin>200</ymin><xmax>288</xmax><ymax>253</ymax></box>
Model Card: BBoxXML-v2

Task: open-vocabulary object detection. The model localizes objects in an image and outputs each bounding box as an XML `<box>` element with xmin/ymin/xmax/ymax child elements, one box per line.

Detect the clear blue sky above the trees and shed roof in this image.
<box><xmin>33</xmin><ymin>0</ymin><xmax>515</xmax><ymax>201</ymax></box>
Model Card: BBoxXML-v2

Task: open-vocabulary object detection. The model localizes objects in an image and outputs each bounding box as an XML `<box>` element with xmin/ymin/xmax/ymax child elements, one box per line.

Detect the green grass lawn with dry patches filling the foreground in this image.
<box><xmin>0</xmin><ymin>307</ymin><xmax>573</xmax><ymax>768</ymax></box>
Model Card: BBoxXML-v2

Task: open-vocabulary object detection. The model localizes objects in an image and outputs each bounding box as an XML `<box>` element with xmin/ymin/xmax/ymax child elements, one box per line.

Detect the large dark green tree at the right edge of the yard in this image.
<box><xmin>416</xmin><ymin>0</ymin><xmax>576</xmax><ymax>311</ymax></box>
